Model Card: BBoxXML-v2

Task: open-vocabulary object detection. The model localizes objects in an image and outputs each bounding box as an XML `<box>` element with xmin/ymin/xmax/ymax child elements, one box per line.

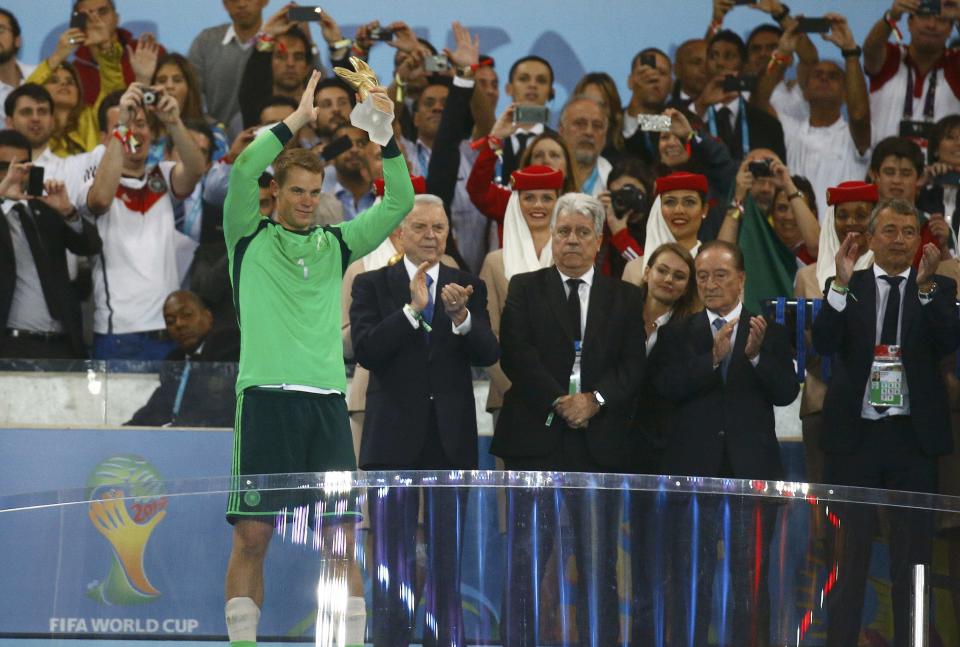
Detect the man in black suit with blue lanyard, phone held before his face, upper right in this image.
<box><xmin>691</xmin><ymin>29</ymin><xmax>787</xmax><ymax>162</ymax></box>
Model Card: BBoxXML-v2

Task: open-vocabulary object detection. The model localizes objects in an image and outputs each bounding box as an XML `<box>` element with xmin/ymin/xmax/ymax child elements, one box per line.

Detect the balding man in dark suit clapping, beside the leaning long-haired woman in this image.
<box><xmin>657</xmin><ymin>240</ymin><xmax>800</xmax><ymax>647</ymax></box>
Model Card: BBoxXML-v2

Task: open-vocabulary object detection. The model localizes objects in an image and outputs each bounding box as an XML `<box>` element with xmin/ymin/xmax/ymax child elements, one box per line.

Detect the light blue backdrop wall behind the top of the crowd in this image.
<box><xmin>3</xmin><ymin>0</ymin><xmax>890</xmax><ymax>113</ymax></box>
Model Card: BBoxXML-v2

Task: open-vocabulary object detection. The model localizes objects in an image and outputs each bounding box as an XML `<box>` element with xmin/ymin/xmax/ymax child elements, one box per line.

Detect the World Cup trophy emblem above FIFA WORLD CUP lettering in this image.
<box><xmin>87</xmin><ymin>455</ymin><xmax>167</xmax><ymax>606</ymax></box>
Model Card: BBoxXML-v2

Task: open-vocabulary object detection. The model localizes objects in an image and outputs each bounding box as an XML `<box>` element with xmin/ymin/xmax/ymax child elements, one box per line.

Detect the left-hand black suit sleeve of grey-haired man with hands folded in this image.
<box><xmin>500</xmin><ymin>275</ymin><xmax>567</xmax><ymax>411</ymax></box>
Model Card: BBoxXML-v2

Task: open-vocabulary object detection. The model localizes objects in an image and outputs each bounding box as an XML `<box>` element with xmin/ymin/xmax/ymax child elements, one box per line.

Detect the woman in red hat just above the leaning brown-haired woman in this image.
<box><xmin>623</xmin><ymin>172</ymin><xmax>709</xmax><ymax>285</ymax></box>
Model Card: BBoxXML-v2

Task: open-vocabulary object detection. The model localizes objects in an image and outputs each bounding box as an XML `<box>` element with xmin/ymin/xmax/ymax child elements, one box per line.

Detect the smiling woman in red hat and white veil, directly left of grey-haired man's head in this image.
<box><xmin>480</xmin><ymin>163</ymin><xmax>565</xmax><ymax>422</ymax></box>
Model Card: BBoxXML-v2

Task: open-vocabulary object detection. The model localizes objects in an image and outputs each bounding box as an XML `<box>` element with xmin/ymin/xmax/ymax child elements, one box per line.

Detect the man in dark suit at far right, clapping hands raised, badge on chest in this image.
<box><xmin>813</xmin><ymin>199</ymin><xmax>960</xmax><ymax>647</ymax></box>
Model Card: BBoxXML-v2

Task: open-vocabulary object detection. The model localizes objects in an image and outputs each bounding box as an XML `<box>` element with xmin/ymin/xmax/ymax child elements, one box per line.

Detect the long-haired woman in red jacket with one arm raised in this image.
<box><xmin>467</xmin><ymin>106</ymin><xmax>577</xmax><ymax>243</ymax></box>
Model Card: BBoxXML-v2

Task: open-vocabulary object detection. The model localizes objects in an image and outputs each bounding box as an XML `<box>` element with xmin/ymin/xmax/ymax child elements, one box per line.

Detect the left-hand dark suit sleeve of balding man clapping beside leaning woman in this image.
<box><xmin>656</xmin><ymin>322</ymin><xmax>723</xmax><ymax>402</ymax></box>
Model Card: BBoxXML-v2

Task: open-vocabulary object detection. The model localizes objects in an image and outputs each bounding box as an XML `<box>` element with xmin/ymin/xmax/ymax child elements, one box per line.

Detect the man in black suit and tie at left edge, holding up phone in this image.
<box><xmin>0</xmin><ymin>130</ymin><xmax>101</xmax><ymax>359</ymax></box>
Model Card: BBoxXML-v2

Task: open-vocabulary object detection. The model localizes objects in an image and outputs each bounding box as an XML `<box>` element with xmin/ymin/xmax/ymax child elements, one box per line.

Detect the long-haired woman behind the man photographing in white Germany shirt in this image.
<box><xmin>148</xmin><ymin>53</ymin><xmax>230</xmax><ymax>163</ymax></box>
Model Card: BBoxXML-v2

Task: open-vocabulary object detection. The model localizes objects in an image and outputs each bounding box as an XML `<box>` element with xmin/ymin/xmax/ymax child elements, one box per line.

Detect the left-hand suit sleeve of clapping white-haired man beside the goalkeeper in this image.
<box><xmin>350</xmin><ymin>272</ymin><xmax>419</xmax><ymax>371</ymax></box>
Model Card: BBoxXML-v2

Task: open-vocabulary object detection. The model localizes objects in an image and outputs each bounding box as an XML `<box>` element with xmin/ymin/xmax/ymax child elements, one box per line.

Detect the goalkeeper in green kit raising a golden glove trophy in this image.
<box><xmin>223</xmin><ymin>71</ymin><xmax>413</xmax><ymax>647</ymax></box>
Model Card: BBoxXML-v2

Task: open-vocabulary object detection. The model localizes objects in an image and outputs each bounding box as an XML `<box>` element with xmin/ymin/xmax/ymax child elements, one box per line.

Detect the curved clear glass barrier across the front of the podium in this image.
<box><xmin>0</xmin><ymin>474</ymin><xmax>960</xmax><ymax>647</ymax></box>
